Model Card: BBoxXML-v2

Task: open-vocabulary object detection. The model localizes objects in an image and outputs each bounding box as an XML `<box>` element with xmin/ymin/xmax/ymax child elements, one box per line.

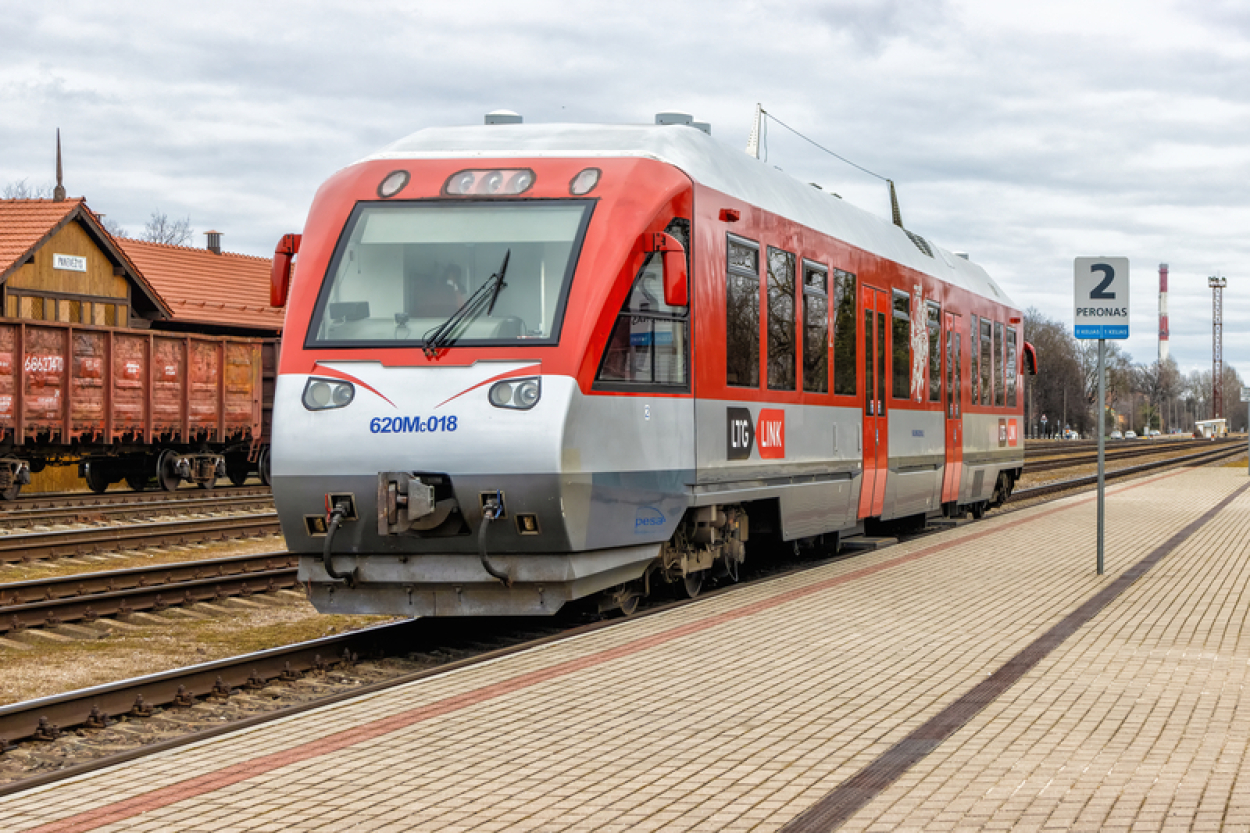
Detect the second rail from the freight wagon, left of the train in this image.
<box><xmin>0</xmin><ymin>512</ymin><xmax>281</xmax><ymax>563</ymax></box>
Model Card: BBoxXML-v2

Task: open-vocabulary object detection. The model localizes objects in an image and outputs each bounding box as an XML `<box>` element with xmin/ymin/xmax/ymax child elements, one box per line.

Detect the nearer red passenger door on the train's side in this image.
<box><xmin>859</xmin><ymin>286</ymin><xmax>890</xmax><ymax>518</ymax></box>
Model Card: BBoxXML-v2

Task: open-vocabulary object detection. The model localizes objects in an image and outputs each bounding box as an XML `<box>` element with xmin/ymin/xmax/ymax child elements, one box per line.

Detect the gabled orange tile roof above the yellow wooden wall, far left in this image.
<box><xmin>0</xmin><ymin>196</ymin><xmax>170</xmax><ymax>318</ymax></box>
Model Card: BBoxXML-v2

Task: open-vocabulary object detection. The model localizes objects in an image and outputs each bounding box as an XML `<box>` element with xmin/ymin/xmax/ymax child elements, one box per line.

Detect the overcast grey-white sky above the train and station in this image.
<box><xmin>0</xmin><ymin>0</ymin><xmax>1250</xmax><ymax>375</ymax></box>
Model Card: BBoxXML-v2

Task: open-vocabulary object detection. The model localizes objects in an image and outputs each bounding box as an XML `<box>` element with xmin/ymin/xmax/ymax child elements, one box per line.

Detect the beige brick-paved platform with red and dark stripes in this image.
<box><xmin>7</xmin><ymin>468</ymin><xmax>1250</xmax><ymax>833</ymax></box>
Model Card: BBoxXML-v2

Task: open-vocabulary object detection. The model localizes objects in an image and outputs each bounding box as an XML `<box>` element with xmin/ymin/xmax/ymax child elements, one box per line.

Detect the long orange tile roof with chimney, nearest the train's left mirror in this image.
<box><xmin>115</xmin><ymin>238</ymin><xmax>283</xmax><ymax>331</ymax></box>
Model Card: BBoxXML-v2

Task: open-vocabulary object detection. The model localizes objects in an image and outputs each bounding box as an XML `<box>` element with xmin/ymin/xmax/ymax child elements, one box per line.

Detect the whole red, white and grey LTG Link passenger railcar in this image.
<box><xmin>271</xmin><ymin>113</ymin><xmax>1033</xmax><ymax>617</ymax></box>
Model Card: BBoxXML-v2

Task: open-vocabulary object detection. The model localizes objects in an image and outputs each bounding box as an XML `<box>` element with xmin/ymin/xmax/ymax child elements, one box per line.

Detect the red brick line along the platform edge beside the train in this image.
<box><xmin>28</xmin><ymin>472</ymin><xmax>1180</xmax><ymax>833</ymax></box>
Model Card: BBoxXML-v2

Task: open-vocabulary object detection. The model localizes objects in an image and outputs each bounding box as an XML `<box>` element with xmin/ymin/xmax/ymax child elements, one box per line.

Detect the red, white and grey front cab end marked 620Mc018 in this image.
<box><xmin>271</xmin><ymin>129</ymin><xmax>693</xmax><ymax>617</ymax></box>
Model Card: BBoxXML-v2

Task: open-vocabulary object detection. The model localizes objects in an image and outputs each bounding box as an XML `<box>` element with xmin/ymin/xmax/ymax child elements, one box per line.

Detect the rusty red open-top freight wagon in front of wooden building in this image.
<box><xmin>0</xmin><ymin>320</ymin><xmax>276</xmax><ymax>499</ymax></box>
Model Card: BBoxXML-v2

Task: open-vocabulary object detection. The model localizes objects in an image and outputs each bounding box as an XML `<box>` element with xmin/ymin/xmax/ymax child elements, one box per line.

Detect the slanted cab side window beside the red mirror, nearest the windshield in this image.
<box><xmin>596</xmin><ymin>247</ymin><xmax>689</xmax><ymax>386</ymax></box>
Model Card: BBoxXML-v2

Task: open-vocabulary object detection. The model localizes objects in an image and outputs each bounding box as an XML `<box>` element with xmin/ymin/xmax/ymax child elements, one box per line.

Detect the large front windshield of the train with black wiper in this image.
<box><xmin>309</xmin><ymin>200</ymin><xmax>591</xmax><ymax>346</ymax></box>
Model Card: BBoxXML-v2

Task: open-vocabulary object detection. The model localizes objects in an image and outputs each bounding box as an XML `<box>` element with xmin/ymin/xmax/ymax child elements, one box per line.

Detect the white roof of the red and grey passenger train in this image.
<box><xmin>361</xmin><ymin>124</ymin><xmax>1014</xmax><ymax>306</ymax></box>
